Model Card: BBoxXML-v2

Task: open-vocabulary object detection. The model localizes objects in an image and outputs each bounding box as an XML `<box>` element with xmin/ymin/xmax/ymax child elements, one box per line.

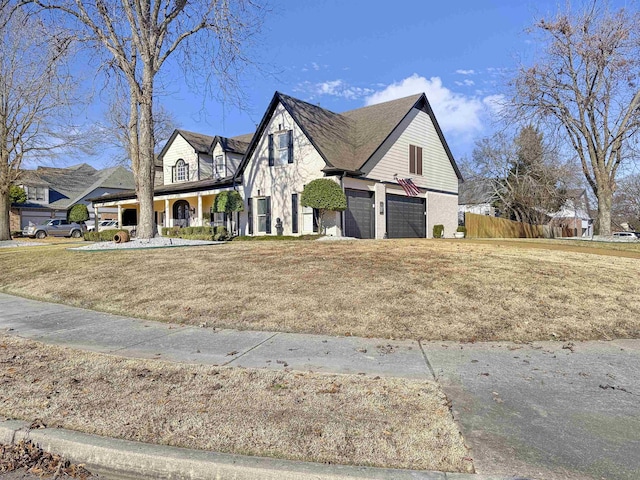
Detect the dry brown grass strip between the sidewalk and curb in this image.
<box><xmin>0</xmin><ymin>335</ymin><xmax>473</xmax><ymax>472</ymax></box>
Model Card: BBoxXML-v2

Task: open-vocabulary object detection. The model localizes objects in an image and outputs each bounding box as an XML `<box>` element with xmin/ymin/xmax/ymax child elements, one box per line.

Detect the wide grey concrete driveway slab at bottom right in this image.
<box><xmin>423</xmin><ymin>340</ymin><xmax>640</xmax><ymax>480</ymax></box>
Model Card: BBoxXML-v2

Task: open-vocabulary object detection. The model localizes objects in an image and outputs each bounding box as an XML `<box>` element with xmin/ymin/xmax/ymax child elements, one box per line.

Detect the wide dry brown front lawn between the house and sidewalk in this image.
<box><xmin>0</xmin><ymin>240</ymin><xmax>640</xmax><ymax>341</ymax></box>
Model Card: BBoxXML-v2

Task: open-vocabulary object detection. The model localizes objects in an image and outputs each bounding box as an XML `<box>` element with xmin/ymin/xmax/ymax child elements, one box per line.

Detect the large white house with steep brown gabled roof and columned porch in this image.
<box><xmin>93</xmin><ymin>92</ymin><xmax>461</xmax><ymax>238</ymax></box>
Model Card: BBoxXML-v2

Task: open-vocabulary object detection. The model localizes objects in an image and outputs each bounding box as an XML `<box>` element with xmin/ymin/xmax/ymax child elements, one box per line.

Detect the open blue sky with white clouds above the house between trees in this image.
<box><xmin>84</xmin><ymin>0</ymin><xmax>618</xmax><ymax>169</ymax></box>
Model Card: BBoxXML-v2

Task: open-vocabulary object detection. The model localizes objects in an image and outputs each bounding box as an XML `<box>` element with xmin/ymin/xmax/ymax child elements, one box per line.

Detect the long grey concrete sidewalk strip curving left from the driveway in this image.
<box><xmin>0</xmin><ymin>294</ymin><xmax>433</xmax><ymax>379</ymax></box>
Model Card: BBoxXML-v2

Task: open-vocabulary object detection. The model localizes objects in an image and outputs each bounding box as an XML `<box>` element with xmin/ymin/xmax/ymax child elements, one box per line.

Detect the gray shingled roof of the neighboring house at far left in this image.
<box><xmin>31</xmin><ymin>164</ymin><xmax>135</xmax><ymax>209</ymax></box>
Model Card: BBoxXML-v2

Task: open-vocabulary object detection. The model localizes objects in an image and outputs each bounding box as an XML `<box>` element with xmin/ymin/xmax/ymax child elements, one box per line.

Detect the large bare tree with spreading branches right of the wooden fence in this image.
<box><xmin>512</xmin><ymin>0</ymin><xmax>640</xmax><ymax>235</ymax></box>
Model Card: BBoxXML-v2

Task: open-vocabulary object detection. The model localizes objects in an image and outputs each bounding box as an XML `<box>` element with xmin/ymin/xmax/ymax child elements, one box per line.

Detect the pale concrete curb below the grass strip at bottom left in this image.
<box><xmin>0</xmin><ymin>420</ymin><xmax>506</xmax><ymax>480</ymax></box>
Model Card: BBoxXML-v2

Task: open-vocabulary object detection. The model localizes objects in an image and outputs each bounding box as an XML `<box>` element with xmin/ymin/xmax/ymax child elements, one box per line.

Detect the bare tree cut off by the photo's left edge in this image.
<box><xmin>0</xmin><ymin>4</ymin><xmax>75</xmax><ymax>240</ymax></box>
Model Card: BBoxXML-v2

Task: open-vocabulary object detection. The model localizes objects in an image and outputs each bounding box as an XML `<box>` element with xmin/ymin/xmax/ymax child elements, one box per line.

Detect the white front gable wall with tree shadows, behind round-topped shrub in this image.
<box><xmin>242</xmin><ymin>105</ymin><xmax>338</xmax><ymax>235</ymax></box>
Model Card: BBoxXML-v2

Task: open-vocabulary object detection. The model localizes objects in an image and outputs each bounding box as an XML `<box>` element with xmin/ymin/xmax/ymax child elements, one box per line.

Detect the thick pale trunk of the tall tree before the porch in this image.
<box><xmin>136</xmin><ymin>72</ymin><xmax>155</xmax><ymax>239</ymax></box>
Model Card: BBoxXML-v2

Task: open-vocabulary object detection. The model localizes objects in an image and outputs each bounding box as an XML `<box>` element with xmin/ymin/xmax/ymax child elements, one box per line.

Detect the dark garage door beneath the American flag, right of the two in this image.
<box><xmin>387</xmin><ymin>194</ymin><xmax>427</xmax><ymax>238</ymax></box>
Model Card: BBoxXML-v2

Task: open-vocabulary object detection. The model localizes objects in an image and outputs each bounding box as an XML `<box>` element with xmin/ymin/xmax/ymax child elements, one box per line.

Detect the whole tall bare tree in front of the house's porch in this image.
<box><xmin>30</xmin><ymin>0</ymin><xmax>261</xmax><ymax>238</ymax></box>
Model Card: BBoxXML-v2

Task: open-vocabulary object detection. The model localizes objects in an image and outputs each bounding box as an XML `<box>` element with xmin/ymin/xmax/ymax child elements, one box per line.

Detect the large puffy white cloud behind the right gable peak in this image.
<box><xmin>366</xmin><ymin>73</ymin><xmax>497</xmax><ymax>137</ymax></box>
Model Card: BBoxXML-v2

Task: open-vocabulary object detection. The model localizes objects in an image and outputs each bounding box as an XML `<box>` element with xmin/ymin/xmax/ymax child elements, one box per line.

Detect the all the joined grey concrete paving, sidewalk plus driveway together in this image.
<box><xmin>0</xmin><ymin>294</ymin><xmax>640</xmax><ymax>480</ymax></box>
